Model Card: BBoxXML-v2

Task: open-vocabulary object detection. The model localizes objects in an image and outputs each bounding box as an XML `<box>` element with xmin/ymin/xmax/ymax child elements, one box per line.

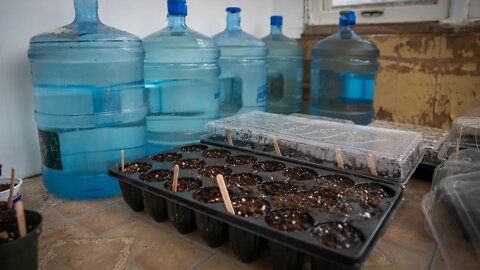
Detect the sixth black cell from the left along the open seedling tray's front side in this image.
<box><xmin>268</xmin><ymin>241</ymin><xmax>305</xmax><ymax>270</ymax></box>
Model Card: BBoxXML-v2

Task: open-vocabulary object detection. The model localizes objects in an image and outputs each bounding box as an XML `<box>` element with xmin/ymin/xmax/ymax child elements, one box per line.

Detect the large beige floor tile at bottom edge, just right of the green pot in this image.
<box><xmin>40</xmin><ymin>237</ymin><xmax>133</xmax><ymax>270</ymax></box>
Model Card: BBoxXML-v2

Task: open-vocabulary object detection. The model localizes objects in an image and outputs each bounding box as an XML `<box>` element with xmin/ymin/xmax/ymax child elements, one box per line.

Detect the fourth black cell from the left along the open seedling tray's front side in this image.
<box><xmin>195</xmin><ymin>212</ymin><xmax>228</xmax><ymax>248</ymax></box>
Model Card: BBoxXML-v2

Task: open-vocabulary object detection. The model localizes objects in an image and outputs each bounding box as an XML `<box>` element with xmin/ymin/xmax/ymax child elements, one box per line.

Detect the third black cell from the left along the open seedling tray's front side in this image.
<box><xmin>167</xmin><ymin>201</ymin><xmax>195</xmax><ymax>234</ymax></box>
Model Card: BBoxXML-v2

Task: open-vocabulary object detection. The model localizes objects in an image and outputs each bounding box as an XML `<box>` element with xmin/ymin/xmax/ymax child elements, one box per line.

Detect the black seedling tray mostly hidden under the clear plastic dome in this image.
<box><xmin>201</xmin><ymin>135</ymin><xmax>416</xmax><ymax>188</ymax></box>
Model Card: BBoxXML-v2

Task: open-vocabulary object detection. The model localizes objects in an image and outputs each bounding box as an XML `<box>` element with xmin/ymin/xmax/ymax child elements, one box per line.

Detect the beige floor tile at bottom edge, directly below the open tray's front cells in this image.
<box><xmin>135</xmin><ymin>237</ymin><xmax>210</xmax><ymax>270</ymax></box>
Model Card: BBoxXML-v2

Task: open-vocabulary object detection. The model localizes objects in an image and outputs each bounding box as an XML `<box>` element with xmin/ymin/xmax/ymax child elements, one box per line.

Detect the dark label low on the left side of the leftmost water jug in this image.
<box><xmin>38</xmin><ymin>129</ymin><xmax>63</xmax><ymax>170</ymax></box>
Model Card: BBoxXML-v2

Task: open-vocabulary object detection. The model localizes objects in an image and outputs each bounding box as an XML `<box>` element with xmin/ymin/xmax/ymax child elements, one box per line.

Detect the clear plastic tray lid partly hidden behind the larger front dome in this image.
<box><xmin>369</xmin><ymin>120</ymin><xmax>448</xmax><ymax>167</ymax></box>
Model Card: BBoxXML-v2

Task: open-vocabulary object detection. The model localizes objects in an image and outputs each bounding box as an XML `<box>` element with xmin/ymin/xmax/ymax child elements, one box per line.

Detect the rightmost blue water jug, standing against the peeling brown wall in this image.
<box><xmin>308</xmin><ymin>11</ymin><xmax>379</xmax><ymax>125</ymax></box>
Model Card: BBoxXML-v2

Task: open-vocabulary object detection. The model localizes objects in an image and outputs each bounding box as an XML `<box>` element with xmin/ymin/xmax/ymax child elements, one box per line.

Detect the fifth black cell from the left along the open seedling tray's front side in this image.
<box><xmin>228</xmin><ymin>226</ymin><xmax>261</xmax><ymax>263</ymax></box>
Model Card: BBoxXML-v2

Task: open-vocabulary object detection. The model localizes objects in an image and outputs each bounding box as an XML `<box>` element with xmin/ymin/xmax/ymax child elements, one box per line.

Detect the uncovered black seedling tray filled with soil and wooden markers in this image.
<box><xmin>109</xmin><ymin>144</ymin><xmax>403</xmax><ymax>269</ymax></box>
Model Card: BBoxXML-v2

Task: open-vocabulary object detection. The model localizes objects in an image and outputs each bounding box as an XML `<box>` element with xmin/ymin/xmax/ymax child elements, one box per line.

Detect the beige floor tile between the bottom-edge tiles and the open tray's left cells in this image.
<box><xmin>103</xmin><ymin>220</ymin><xmax>171</xmax><ymax>254</ymax></box>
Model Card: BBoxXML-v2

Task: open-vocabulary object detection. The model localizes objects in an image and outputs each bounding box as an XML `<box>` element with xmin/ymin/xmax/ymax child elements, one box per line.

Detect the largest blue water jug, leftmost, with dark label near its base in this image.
<box><xmin>28</xmin><ymin>0</ymin><xmax>147</xmax><ymax>199</ymax></box>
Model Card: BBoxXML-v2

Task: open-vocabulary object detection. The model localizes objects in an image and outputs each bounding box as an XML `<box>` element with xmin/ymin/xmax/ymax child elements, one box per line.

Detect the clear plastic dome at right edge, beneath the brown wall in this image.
<box><xmin>446</xmin><ymin>116</ymin><xmax>480</xmax><ymax>156</ymax></box>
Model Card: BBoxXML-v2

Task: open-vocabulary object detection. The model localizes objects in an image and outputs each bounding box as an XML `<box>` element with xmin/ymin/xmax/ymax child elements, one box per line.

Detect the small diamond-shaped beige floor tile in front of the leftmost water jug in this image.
<box><xmin>77</xmin><ymin>206</ymin><xmax>132</xmax><ymax>235</ymax></box>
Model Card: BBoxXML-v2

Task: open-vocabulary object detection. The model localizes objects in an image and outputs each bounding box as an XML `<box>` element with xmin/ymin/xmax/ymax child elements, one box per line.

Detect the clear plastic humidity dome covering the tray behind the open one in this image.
<box><xmin>205</xmin><ymin>112</ymin><xmax>424</xmax><ymax>179</ymax></box>
